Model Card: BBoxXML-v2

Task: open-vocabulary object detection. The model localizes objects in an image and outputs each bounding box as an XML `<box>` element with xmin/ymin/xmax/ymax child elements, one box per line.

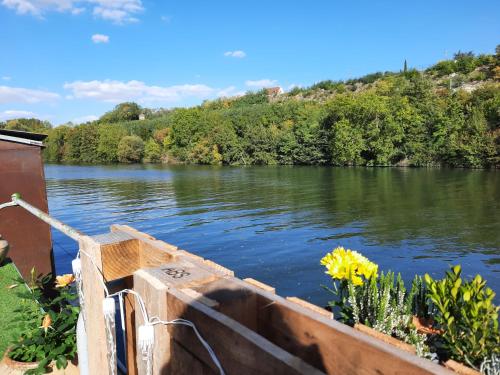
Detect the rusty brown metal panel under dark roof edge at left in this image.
<box><xmin>0</xmin><ymin>140</ymin><xmax>54</xmax><ymax>279</ymax></box>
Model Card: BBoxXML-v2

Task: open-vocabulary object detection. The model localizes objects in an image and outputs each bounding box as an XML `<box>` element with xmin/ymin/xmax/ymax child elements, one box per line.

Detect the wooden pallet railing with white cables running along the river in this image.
<box><xmin>79</xmin><ymin>225</ymin><xmax>451</xmax><ymax>375</ymax></box>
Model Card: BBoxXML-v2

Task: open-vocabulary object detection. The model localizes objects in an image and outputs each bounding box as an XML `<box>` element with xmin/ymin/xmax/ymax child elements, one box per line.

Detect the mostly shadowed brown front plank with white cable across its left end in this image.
<box><xmin>167</xmin><ymin>288</ymin><xmax>322</xmax><ymax>375</ymax></box>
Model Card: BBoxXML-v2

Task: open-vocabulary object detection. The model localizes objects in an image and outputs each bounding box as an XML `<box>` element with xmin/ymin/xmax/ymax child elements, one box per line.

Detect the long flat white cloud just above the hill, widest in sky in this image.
<box><xmin>64</xmin><ymin>80</ymin><xmax>234</xmax><ymax>103</ymax></box>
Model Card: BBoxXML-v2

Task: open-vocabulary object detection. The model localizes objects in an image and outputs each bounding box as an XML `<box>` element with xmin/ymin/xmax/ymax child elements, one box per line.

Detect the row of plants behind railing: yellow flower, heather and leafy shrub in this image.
<box><xmin>321</xmin><ymin>247</ymin><xmax>500</xmax><ymax>375</ymax></box>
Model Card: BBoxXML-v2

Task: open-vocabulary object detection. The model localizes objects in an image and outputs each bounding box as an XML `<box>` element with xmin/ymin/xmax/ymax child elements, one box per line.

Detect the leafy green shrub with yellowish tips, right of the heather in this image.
<box><xmin>425</xmin><ymin>265</ymin><xmax>500</xmax><ymax>368</ymax></box>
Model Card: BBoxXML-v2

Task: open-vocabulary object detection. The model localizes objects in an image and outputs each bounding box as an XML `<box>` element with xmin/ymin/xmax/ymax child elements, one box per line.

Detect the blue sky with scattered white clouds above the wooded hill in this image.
<box><xmin>0</xmin><ymin>0</ymin><xmax>500</xmax><ymax>124</ymax></box>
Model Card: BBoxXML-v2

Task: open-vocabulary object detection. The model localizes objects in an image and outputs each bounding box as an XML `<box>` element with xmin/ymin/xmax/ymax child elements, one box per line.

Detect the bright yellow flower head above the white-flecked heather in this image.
<box><xmin>320</xmin><ymin>247</ymin><xmax>378</xmax><ymax>286</ymax></box>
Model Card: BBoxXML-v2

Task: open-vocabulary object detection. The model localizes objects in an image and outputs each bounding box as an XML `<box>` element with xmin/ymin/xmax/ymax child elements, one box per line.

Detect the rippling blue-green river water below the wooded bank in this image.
<box><xmin>45</xmin><ymin>165</ymin><xmax>500</xmax><ymax>304</ymax></box>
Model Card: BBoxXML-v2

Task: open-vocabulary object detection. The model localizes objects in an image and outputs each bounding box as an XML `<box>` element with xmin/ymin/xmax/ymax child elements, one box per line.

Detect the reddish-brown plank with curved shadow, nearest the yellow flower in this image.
<box><xmin>259</xmin><ymin>300</ymin><xmax>447</xmax><ymax>375</ymax></box>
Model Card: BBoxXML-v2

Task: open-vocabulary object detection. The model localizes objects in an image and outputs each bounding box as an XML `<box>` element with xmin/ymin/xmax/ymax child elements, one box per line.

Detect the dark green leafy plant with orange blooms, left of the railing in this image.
<box><xmin>8</xmin><ymin>270</ymin><xmax>80</xmax><ymax>374</ymax></box>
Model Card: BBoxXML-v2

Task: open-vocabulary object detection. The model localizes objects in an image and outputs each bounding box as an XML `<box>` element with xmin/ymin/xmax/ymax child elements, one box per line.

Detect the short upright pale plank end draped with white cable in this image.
<box><xmin>134</xmin><ymin>270</ymin><xmax>170</xmax><ymax>374</ymax></box>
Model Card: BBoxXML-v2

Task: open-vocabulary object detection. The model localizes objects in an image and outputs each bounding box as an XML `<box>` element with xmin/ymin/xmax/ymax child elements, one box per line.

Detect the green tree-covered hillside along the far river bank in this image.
<box><xmin>0</xmin><ymin>47</ymin><xmax>500</xmax><ymax>168</ymax></box>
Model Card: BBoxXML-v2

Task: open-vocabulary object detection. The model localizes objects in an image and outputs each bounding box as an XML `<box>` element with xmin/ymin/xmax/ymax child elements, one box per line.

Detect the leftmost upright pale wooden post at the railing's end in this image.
<box><xmin>79</xmin><ymin>236</ymin><xmax>112</xmax><ymax>374</ymax></box>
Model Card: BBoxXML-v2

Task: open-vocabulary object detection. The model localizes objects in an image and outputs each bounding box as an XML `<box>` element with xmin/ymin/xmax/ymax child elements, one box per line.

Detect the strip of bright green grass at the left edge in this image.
<box><xmin>0</xmin><ymin>263</ymin><xmax>25</xmax><ymax>358</ymax></box>
